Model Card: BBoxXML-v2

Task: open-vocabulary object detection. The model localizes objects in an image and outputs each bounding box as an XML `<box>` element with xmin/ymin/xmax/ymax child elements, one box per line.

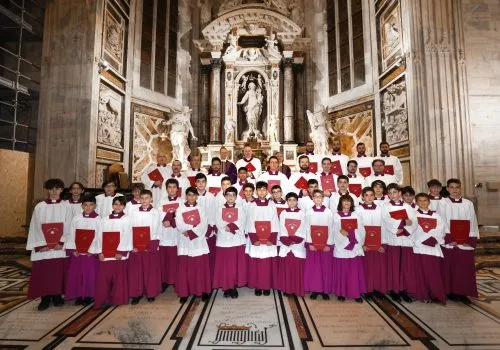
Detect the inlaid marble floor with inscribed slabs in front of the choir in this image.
<box><xmin>0</xmin><ymin>261</ymin><xmax>500</xmax><ymax>350</ymax></box>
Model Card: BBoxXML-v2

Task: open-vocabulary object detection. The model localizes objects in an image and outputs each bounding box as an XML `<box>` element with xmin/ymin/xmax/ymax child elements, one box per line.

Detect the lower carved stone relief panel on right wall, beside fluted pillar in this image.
<box><xmin>380</xmin><ymin>77</ymin><xmax>409</xmax><ymax>146</ymax></box>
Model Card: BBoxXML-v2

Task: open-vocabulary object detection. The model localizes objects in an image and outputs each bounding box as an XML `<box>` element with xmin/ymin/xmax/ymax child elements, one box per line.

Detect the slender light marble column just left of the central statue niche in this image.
<box><xmin>210</xmin><ymin>58</ymin><xmax>222</xmax><ymax>144</ymax></box>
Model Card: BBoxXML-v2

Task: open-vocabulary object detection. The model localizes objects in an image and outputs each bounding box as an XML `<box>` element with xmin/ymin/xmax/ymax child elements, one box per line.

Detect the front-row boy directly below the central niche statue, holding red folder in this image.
<box><xmin>246</xmin><ymin>181</ymin><xmax>279</xmax><ymax>296</ymax></box>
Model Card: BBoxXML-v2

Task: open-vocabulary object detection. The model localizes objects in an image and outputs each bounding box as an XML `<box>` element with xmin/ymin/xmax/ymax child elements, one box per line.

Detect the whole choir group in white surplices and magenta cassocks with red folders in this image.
<box><xmin>27</xmin><ymin>141</ymin><xmax>479</xmax><ymax>310</ymax></box>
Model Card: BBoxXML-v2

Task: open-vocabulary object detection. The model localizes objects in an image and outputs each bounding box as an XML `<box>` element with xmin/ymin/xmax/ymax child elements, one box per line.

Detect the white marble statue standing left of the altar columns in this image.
<box><xmin>166</xmin><ymin>107</ymin><xmax>198</xmax><ymax>164</ymax></box>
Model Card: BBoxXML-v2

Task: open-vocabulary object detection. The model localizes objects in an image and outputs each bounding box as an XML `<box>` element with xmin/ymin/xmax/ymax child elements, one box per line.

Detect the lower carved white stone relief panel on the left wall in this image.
<box><xmin>97</xmin><ymin>83</ymin><xmax>123</xmax><ymax>148</ymax></box>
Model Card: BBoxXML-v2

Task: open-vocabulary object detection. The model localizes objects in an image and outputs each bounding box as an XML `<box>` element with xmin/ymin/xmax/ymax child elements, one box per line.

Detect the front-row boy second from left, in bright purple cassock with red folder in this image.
<box><xmin>64</xmin><ymin>197</ymin><xmax>102</xmax><ymax>306</ymax></box>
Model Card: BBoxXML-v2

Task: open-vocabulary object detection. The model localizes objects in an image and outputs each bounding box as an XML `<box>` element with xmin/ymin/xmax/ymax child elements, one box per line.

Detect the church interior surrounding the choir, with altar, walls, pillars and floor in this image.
<box><xmin>0</xmin><ymin>0</ymin><xmax>500</xmax><ymax>350</ymax></box>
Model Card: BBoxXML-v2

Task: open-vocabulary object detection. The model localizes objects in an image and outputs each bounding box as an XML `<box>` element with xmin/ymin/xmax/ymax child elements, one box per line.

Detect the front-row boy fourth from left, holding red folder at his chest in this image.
<box><xmin>128</xmin><ymin>190</ymin><xmax>161</xmax><ymax>305</ymax></box>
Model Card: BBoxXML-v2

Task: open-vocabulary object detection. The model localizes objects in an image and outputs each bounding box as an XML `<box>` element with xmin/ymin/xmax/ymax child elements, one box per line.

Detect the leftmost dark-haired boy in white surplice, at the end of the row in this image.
<box><xmin>26</xmin><ymin>179</ymin><xmax>73</xmax><ymax>311</ymax></box>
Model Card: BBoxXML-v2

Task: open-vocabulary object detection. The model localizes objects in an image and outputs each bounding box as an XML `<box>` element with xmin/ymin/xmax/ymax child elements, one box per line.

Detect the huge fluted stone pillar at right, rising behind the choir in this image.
<box><xmin>401</xmin><ymin>0</ymin><xmax>474</xmax><ymax>195</ymax></box>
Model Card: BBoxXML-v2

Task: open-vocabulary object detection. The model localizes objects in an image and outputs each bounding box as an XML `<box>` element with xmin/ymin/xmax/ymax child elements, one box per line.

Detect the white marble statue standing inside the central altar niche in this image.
<box><xmin>238</xmin><ymin>81</ymin><xmax>264</xmax><ymax>141</ymax></box>
